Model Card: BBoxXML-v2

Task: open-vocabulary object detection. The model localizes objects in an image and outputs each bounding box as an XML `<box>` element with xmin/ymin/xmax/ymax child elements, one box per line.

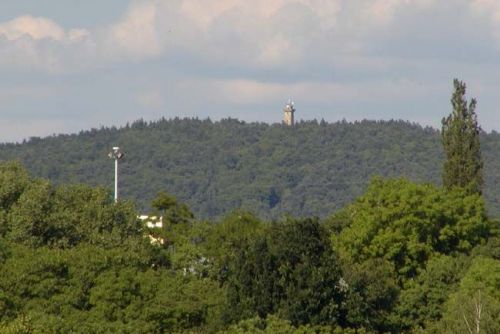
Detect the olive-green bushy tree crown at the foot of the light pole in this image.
<box><xmin>6</xmin><ymin>179</ymin><xmax>142</xmax><ymax>248</ymax></box>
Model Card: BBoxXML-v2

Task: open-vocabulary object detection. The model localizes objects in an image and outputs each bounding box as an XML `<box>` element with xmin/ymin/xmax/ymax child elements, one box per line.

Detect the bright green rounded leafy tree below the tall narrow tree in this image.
<box><xmin>333</xmin><ymin>178</ymin><xmax>492</xmax><ymax>282</ymax></box>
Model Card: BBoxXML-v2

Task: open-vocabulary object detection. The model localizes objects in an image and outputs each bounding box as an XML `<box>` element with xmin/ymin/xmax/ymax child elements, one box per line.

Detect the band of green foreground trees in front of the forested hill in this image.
<box><xmin>0</xmin><ymin>163</ymin><xmax>500</xmax><ymax>334</ymax></box>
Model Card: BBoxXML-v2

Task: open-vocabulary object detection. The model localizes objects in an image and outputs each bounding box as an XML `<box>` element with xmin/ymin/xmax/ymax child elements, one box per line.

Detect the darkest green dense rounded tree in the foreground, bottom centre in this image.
<box><xmin>227</xmin><ymin>219</ymin><xmax>343</xmax><ymax>325</ymax></box>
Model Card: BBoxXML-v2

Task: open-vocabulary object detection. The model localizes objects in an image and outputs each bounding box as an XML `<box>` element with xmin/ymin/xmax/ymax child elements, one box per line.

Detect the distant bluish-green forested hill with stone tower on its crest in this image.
<box><xmin>0</xmin><ymin>119</ymin><xmax>500</xmax><ymax>218</ymax></box>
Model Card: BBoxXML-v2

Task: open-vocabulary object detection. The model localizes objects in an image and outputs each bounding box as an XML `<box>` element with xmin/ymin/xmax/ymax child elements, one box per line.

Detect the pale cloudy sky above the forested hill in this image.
<box><xmin>0</xmin><ymin>0</ymin><xmax>500</xmax><ymax>142</ymax></box>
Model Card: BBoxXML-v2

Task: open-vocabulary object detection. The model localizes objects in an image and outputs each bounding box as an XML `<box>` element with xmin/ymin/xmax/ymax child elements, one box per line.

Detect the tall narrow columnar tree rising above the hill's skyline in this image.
<box><xmin>441</xmin><ymin>79</ymin><xmax>483</xmax><ymax>194</ymax></box>
